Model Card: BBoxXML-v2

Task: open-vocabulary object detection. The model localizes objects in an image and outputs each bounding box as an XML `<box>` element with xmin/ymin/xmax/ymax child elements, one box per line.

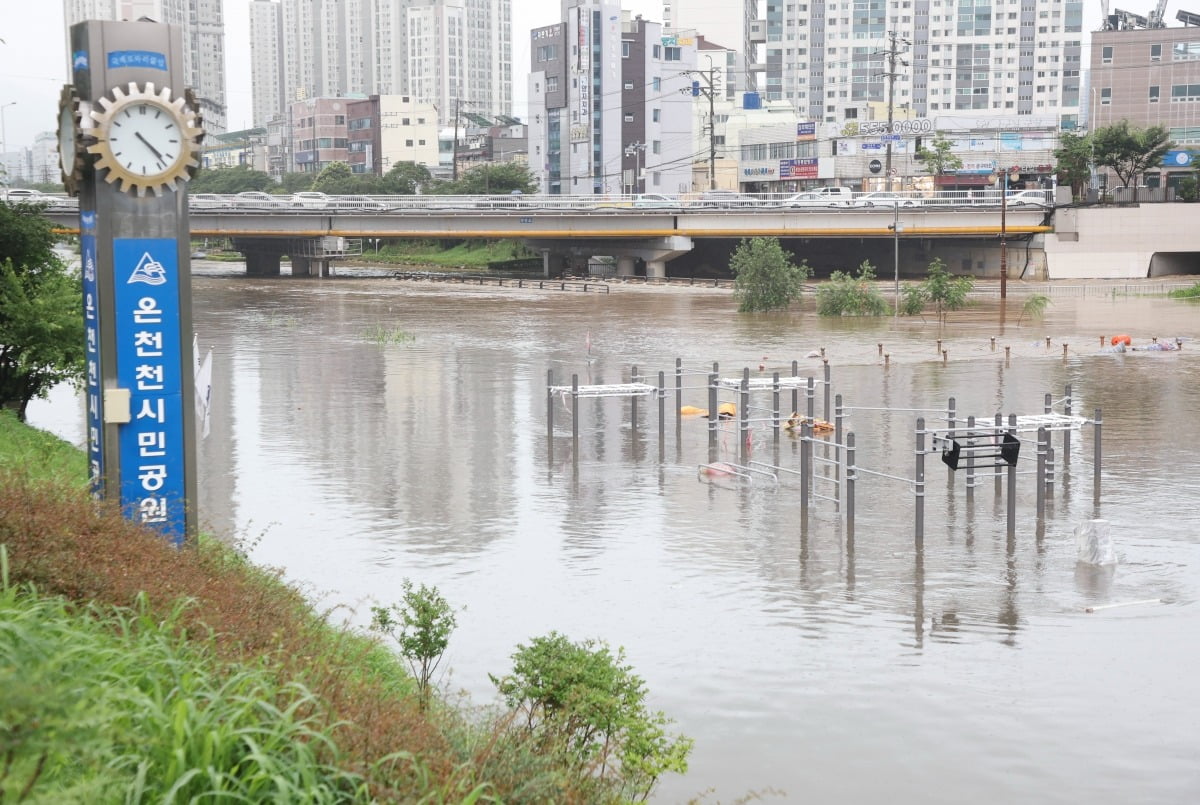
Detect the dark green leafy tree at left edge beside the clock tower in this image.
<box><xmin>0</xmin><ymin>203</ymin><xmax>84</xmax><ymax>421</ymax></box>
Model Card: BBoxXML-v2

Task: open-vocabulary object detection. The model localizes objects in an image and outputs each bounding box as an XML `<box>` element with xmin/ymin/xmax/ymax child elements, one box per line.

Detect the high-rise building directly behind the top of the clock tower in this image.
<box><xmin>62</xmin><ymin>0</ymin><xmax>228</xmax><ymax>134</ymax></box>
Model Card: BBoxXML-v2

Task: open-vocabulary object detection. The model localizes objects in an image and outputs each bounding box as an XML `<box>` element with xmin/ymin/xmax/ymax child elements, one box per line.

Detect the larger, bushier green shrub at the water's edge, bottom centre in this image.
<box><xmin>491</xmin><ymin>632</ymin><xmax>692</xmax><ymax>801</ymax></box>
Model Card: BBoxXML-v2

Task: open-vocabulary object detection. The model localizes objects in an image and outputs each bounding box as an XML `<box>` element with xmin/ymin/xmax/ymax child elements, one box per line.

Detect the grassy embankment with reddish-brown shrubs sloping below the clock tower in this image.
<box><xmin>0</xmin><ymin>411</ymin><xmax>613</xmax><ymax>803</ymax></box>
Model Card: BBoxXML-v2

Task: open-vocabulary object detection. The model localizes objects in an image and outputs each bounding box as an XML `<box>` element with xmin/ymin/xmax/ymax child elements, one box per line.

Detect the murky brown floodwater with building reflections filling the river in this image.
<box><xmin>31</xmin><ymin>277</ymin><xmax>1200</xmax><ymax>803</ymax></box>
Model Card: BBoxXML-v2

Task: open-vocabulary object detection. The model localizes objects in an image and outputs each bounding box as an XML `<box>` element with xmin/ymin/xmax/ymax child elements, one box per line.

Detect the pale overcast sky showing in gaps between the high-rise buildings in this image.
<box><xmin>0</xmin><ymin>0</ymin><xmax>1152</xmax><ymax>150</ymax></box>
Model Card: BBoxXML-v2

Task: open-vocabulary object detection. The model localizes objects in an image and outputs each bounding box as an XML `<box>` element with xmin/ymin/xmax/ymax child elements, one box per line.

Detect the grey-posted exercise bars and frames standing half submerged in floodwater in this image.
<box><xmin>546</xmin><ymin>359</ymin><xmax>1103</xmax><ymax>548</ymax></box>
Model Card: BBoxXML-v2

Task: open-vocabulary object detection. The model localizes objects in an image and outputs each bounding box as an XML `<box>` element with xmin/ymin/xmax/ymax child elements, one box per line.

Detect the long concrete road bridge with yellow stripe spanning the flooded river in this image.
<box><xmin>47</xmin><ymin>197</ymin><xmax>1200</xmax><ymax>280</ymax></box>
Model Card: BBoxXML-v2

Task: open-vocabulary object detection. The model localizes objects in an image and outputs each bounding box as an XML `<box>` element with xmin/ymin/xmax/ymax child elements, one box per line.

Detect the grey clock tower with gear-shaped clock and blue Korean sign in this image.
<box><xmin>59</xmin><ymin>20</ymin><xmax>203</xmax><ymax>545</ymax></box>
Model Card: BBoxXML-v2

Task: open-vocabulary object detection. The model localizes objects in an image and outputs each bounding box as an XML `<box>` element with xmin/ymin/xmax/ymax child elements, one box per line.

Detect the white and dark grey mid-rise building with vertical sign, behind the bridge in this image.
<box><xmin>528</xmin><ymin>0</ymin><xmax>696</xmax><ymax>194</ymax></box>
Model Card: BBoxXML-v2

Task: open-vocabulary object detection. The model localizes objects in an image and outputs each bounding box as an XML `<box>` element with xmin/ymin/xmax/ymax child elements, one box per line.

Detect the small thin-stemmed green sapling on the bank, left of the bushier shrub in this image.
<box><xmin>371</xmin><ymin>578</ymin><xmax>457</xmax><ymax>707</ymax></box>
